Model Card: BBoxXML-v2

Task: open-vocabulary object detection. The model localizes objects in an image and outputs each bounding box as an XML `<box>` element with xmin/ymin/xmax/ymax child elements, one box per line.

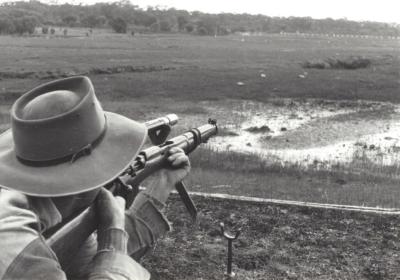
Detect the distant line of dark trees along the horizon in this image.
<box><xmin>0</xmin><ymin>0</ymin><xmax>400</xmax><ymax>36</ymax></box>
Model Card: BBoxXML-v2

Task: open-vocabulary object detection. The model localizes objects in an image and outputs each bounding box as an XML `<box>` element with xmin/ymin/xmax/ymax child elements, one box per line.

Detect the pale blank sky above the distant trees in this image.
<box><xmin>5</xmin><ymin>0</ymin><xmax>400</xmax><ymax>24</ymax></box>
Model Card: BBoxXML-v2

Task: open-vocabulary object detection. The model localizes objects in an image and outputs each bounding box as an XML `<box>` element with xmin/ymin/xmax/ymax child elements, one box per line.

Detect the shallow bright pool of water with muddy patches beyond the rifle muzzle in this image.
<box><xmin>205</xmin><ymin>100</ymin><xmax>400</xmax><ymax>165</ymax></box>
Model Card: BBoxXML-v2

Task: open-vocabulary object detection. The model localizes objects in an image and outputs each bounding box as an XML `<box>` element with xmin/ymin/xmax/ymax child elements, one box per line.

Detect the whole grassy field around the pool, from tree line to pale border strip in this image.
<box><xmin>0</xmin><ymin>30</ymin><xmax>400</xmax><ymax>207</ymax></box>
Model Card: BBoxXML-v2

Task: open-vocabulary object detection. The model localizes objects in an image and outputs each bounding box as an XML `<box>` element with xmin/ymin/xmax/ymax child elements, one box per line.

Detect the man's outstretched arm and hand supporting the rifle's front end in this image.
<box><xmin>45</xmin><ymin>149</ymin><xmax>190</xmax><ymax>278</ymax></box>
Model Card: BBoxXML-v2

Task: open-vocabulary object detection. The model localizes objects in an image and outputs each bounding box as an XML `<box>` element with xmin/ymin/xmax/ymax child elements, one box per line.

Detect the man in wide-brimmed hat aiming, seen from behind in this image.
<box><xmin>0</xmin><ymin>76</ymin><xmax>190</xmax><ymax>280</ymax></box>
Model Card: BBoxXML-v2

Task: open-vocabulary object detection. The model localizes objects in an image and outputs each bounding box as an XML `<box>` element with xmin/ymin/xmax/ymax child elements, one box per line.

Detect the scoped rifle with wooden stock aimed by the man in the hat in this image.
<box><xmin>44</xmin><ymin>114</ymin><xmax>218</xmax><ymax>267</ymax></box>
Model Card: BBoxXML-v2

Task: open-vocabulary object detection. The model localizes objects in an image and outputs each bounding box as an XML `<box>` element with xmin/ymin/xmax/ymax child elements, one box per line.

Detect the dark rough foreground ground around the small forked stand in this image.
<box><xmin>143</xmin><ymin>197</ymin><xmax>400</xmax><ymax>280</ymax></box>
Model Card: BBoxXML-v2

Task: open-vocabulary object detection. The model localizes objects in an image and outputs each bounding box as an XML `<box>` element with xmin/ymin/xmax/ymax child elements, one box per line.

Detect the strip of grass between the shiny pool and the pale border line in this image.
<box><xmin>188</xmin><ymin>147</ymin><xmax>400</xmax><ymax>208</ymax></box>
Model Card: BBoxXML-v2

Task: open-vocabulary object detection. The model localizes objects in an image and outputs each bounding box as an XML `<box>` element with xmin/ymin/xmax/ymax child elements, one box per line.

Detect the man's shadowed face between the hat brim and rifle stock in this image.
<box><xmin>52</xmin><ymin>188</ymin><xmax>100</xmax><ymax>219</ymax></box>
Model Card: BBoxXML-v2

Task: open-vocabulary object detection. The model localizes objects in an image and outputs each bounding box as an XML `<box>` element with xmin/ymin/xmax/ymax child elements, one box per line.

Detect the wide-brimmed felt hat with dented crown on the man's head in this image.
<box><xmin>0</xmin><ymin>76</ymin><xmax>147</xmax><ymax>197</ymax></box>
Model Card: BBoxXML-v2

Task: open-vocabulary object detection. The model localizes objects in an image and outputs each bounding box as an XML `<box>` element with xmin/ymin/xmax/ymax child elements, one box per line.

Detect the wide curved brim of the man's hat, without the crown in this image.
<box><xmin>0</xmin><ymin>112</ymin><xmax>147</xmax><ymax>197</ymax></box>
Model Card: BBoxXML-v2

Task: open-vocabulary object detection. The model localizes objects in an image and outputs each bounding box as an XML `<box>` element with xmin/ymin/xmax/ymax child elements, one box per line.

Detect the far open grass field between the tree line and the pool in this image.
<box><xmin>0</xmin><ymin>32</ymin><xmax>400</xmax><ymax>102</ymax></box>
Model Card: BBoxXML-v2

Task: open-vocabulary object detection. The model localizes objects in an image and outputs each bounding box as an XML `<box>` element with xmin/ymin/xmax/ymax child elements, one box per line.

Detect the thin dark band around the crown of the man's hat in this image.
<box><xmin>16</xmin><ymin>119</ymin><xmax>107</xmax><ymax>167</ymax></box>
